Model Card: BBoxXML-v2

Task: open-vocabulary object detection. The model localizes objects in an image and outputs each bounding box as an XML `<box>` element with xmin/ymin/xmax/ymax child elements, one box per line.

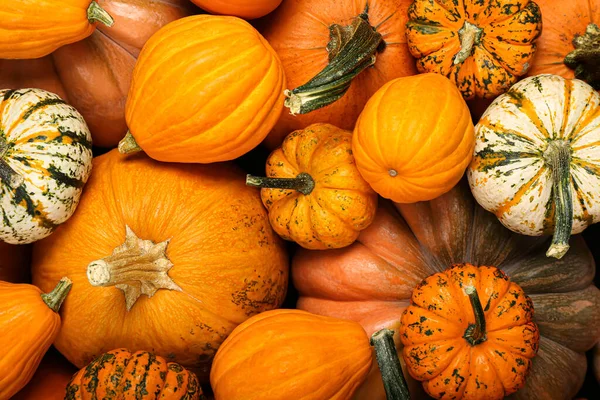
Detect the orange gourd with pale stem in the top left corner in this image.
<box><xmin>0</xmin><ymin>0</ymin><xmax>114</xmax><ymax>58</ymax></box>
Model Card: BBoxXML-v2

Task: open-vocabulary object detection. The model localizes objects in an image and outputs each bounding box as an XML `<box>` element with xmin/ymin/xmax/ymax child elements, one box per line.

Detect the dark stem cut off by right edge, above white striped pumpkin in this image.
<box><xmin>565</xmin><ymin>24</ymin><xmax>600</xmax><ymax>90</ymax></box>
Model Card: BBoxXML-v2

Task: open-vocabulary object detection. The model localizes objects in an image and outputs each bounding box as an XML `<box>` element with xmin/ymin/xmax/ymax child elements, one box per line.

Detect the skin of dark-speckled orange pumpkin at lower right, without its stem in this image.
<box><xmin>398</xmin><ymin>264</ymin><xmax>540</xmax><ymax>399</ymax></box>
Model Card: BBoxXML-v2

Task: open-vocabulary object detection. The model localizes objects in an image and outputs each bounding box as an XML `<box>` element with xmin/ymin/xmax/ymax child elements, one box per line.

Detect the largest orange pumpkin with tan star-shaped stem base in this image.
<box><xmin>32</xmin><ymin>149</ymin><xmax>288</xmax><ymax>378</ymax></box>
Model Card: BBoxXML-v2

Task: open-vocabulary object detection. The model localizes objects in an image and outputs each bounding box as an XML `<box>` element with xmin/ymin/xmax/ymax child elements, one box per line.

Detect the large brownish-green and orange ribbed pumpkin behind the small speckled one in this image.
<box><xmin>292</xmin><ymin>182</ymin><xmax>600</xmax><ymax>400</ymax></box>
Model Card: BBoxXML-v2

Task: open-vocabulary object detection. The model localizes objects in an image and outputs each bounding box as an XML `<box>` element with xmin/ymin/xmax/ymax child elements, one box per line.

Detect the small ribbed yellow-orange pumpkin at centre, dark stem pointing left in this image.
<box><xmin>246</xmin><ymin>124</ymin><xmax>377</xmax><ymax>250</ymax></box>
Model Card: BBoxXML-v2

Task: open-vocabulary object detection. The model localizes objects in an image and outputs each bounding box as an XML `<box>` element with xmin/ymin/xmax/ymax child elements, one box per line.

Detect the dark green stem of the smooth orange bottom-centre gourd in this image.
<box><xmin>371</xmin><ymin>329</ymin><xmax>410</xmax><ymax>400</ymax></box>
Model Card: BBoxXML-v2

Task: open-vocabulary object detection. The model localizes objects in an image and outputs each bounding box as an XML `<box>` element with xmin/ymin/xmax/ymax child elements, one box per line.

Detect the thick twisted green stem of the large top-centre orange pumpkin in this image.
<box><xmin>284</xmin><ymin>6</ymin><xmax>385</xmax><ymax>115</ymax></box>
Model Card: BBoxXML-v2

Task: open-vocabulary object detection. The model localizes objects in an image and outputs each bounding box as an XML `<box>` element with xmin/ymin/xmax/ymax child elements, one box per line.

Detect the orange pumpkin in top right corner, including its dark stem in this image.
<box><xmin>528</xmin><ymin>0</ymin><xmax>600</xmax><ymax>90</ymax></box>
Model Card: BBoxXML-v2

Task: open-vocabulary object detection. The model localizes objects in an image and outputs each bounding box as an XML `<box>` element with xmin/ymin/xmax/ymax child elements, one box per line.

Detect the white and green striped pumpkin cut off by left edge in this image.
<box><xmin>0</xmin><ymin>89</ymin><xmax>92</xmax><ymax>244</ymax></box>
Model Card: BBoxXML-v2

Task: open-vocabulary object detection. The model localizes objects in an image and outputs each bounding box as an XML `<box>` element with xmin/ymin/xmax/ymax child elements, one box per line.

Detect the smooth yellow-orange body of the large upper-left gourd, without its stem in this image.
<box><xmin>125</xmin><ymin>15</ymin><xmax>285</xmax><ymax>163</ymax></box>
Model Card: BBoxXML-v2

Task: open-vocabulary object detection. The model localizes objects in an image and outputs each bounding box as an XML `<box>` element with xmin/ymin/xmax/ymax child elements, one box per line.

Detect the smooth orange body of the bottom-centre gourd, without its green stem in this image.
<box><xmin>210</xmin><ymin>309</ymin><xmax>372</xmax><ymax>400</ymax></box>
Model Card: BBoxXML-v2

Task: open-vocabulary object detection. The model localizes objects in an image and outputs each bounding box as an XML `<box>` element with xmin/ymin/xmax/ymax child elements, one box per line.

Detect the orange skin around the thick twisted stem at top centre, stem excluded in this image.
<box><xmin>261</xmin><ymin>0</ymin><xmax>417</xmax><ymax>149</ymax></box>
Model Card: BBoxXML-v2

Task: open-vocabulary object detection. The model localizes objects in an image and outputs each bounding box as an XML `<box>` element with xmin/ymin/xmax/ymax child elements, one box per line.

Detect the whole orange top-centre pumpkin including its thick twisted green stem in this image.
<box><xmin>261</xmin><ymin>0</ymin><xmax>417</xmax><ymax>149</ymax></box>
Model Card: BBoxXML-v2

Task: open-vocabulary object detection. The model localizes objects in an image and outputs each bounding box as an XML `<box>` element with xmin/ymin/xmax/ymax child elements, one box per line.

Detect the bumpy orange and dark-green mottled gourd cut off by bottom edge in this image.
<box><xmin>65</xmin><ymin>349</ymin><xmax>202</xmax><ymax>400</ymax></box>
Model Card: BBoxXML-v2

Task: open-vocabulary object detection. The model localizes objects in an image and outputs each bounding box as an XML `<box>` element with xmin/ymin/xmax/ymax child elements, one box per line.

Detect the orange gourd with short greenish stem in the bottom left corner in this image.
<box><xmin>0</xmin><ymin>278</ymin><xmax>71</xmax><ymax>399</ymax></box>
